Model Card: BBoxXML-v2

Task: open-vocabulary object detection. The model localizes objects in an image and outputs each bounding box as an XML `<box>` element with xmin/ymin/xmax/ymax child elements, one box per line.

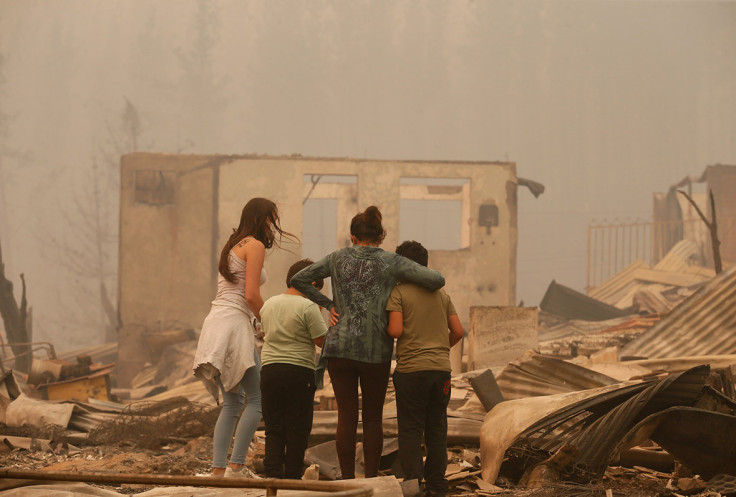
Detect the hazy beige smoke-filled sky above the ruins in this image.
<box><xmin>0</xmin><ymin>0</ymin><xmax>736</xmax><ymax>349</ymax></box>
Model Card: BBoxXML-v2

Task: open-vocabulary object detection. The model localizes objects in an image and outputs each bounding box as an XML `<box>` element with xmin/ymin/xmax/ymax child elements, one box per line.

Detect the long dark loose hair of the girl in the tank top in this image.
<box><xmin>218</xmin><ymin>197</ymin><xmax>294</xmax><ymax>283</ymax></box>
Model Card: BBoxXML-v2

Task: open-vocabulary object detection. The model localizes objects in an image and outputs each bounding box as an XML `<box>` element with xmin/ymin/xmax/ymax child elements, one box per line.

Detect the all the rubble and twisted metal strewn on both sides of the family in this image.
<box><xmin>0</xmin><ymin>242</ymin><xmax>736</xmax><ymax>497</ymax></box>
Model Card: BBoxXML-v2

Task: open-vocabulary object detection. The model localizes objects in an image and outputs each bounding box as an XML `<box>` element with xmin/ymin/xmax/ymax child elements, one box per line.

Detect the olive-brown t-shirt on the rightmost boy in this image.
<box><xmin>386</xmin><ymin>283</ymin><xmax>457</xmax><ymax>373</ymax></box>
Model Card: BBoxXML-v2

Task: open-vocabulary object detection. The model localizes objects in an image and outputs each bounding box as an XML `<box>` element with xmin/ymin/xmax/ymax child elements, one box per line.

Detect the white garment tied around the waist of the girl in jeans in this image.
<box><xmin>192</xmin><ymin>305</ymin><xmax>256</xmax><ymax>404</ymax></box>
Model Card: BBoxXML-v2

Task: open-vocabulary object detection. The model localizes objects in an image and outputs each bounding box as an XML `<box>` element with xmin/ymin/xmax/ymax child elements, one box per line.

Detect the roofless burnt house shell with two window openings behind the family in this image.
<box><xmin>118</xmin><ymin>153</ymin><xmax>543</xmax><ymax>384</ymax></box>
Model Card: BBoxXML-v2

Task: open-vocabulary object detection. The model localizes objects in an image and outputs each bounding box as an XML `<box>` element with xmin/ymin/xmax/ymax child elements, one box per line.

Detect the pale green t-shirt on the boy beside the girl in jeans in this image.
<box><xmin>261</xmin><ymin>293</ymin><xmax>327</xmax><ymax>369</ymax></box>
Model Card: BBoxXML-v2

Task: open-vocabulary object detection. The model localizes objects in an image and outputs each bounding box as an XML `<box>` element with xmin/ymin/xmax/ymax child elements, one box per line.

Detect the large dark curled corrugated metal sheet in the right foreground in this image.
<box><xmin>481</xmin><ymin>365</ymin><xmax>720</xmax><ymax>482</ymax></box>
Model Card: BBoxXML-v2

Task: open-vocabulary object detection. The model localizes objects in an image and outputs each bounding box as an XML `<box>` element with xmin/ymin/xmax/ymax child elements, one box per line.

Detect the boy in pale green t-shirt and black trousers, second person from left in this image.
<box><xmin>261</xmin><ymin>259</ymin><xmax>327</xmax><ymax>479</ymax></box>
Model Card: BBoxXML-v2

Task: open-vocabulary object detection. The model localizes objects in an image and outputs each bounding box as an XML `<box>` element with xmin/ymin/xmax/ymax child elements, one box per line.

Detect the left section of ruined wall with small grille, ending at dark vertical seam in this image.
<box><xmin>118</xmin><ymin>154</ymin><xmax>219</xmax><ymax>379</ymax></box>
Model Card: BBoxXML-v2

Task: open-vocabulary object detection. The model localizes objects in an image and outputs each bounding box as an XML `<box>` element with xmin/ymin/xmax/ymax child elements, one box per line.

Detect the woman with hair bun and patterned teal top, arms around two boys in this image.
<box><xmin>291</xmin><ymin>206</ymin><xmax>445</xmax><ymax>479</ymax></box>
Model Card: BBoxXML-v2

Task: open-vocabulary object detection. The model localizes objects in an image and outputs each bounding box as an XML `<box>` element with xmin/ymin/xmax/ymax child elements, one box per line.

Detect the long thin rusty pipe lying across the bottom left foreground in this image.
<box><xmin>0</xmin><ymin>469</ymin><xmax>373</xmax><ymax>497</ymax></box>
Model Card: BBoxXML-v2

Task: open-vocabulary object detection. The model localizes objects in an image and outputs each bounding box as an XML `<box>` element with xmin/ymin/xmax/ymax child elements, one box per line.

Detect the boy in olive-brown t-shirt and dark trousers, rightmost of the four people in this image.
<box><xmin>386</xmin><ymin>241</ymin><xmax>464</xmax><ymax>496</ymax></box>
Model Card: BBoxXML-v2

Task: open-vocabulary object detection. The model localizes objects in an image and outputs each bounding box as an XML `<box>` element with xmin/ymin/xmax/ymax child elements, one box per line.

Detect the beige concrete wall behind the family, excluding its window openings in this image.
<box><xmin>119</xmin><ymin>153</ymin><xmax>517</xmax><ymax>384</ymax></box>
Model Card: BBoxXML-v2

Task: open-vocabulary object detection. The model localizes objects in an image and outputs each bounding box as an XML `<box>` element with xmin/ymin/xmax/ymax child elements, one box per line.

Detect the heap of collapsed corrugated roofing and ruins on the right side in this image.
<box><xmin>468</xmin><ymin>166</ymin><xmax>736</xmax><ymax>495</ymax></box>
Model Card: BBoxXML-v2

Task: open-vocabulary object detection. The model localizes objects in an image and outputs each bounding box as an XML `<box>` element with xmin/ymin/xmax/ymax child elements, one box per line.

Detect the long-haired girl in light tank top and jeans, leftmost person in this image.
<box><xmin>193</xmin><ymin>198</ymin><xmax>292</xmax><ymax>477</ymax></box>
